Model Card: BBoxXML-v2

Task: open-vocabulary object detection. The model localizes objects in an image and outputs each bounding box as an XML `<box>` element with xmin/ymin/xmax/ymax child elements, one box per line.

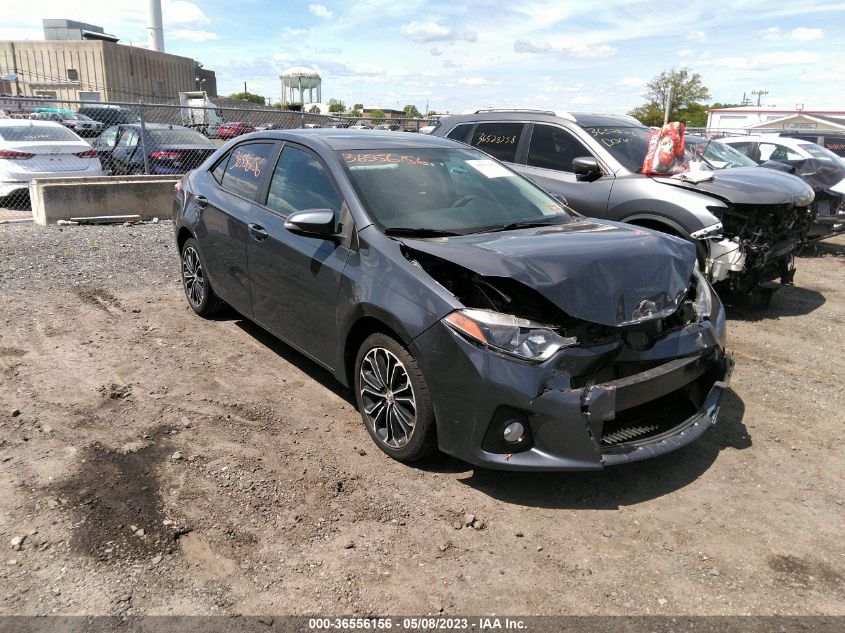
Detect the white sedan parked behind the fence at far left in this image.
<box><xmin>0</xmin><ymin>119</ymin><xmax>103</xmax><ymax>198</ymax></box>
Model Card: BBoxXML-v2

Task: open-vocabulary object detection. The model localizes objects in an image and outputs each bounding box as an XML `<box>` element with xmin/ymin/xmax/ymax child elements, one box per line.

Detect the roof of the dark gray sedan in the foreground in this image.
<box><xmin>256</xmin><ymin>128</ymin><xmax>466</xmax><ymax>150</ymax></box>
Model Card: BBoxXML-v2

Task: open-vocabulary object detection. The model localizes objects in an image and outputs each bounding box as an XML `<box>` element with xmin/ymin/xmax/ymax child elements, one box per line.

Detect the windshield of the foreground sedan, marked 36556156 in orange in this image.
<box><xmin>338</xmin><ymin>148</ymin><xmax>572</xmax><ymax>235</ymax></box>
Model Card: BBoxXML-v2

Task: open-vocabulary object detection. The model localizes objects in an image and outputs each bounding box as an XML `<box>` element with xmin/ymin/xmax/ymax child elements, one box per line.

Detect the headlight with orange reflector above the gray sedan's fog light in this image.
<box><xmin>443</xmin><ymin>309</ymin><xmax>578</xmax><ymax>361</ymax></box>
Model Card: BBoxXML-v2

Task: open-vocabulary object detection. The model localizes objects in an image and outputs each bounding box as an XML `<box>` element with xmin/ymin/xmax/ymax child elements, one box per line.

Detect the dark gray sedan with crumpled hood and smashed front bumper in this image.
<box><xmin>173</xmin><ymin>130</ymin><xmax>732</xmax><ymax>470</ymax></box>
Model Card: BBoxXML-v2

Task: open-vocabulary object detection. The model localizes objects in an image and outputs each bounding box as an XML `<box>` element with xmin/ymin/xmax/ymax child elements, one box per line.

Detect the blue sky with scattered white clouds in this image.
<box><xmin>0</xmin><ymin>0</ymin><xmax>845</xmax><ymax>112</ymax></box>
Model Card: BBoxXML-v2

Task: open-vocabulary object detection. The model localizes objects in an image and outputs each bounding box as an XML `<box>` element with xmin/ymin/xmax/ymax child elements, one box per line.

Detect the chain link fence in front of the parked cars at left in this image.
<box><xmin>0</xmin><ymin>97</ymin><xmax>434</xmax><ymax>210</ymax></box>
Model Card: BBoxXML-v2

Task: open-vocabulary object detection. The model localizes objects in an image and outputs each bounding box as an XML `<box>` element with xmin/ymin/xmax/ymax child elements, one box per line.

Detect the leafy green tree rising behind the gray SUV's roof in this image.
<box><xmin>628</xmin><ymin>68</ymin><xmax>710</xmax><ymax>125</ymax></box>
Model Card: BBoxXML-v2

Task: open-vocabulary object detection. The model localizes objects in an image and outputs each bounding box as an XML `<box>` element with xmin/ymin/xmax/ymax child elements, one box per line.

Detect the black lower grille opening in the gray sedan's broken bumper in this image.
<box><xmin>601</xmin><ymin>389</ymin><xmax>696</xmax><ymax>446</ymax></box>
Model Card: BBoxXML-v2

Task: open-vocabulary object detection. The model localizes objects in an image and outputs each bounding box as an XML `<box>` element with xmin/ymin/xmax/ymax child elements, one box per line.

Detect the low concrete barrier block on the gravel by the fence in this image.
<box><xmin>29</xmin><ymin>176</ymin><xmax>181</xmax><ymax>224</ymax></box>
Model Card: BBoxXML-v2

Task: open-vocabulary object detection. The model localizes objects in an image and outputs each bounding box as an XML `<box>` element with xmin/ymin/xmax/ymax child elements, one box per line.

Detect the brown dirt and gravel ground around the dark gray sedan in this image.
<box><xmin>0</xmin><ymin>226</ymin><xmax>845</xmax><ymax>615</ymax></box>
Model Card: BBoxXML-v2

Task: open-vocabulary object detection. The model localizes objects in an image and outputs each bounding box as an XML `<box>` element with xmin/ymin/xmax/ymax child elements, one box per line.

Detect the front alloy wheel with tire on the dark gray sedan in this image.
<box><xmin>355</xmin><ymin>334</ymin><xmax>436</xmax><ymax>462</ymax></box>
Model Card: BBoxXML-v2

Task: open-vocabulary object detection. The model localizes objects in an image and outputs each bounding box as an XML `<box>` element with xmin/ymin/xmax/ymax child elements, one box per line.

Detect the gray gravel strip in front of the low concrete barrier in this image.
<box><xmin>0</xmin><ymin>220</ymin><xmax>179</xmax><ymax>292</ymax></box>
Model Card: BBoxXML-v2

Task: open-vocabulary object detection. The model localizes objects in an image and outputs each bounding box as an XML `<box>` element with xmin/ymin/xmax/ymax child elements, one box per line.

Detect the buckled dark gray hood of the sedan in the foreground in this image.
<box><xmin>401</xmin><ymin>219</ymin><xmax>696</xmax><ymax>327</ymax></box>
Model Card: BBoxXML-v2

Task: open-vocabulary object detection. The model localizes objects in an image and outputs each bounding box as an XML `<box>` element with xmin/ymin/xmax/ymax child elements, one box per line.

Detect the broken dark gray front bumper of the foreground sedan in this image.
<box><xmin>412</xmin><ymin>305</ymin><xmax>733</xmax><ymax>470</ymax></box>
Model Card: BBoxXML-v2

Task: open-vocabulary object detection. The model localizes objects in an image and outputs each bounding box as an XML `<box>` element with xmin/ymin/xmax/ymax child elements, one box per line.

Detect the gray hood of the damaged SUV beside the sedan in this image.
<box><xmin>654</xmin><ymin>167</ymin><xmax>814</xmax><ymax>207</ymax></box>
